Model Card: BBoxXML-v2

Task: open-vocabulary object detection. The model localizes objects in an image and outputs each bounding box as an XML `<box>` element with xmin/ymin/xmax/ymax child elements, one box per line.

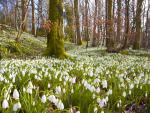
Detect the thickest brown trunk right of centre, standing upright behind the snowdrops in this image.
<box><xmin>106</xmin><ymin>0</ymin><xmax>114</xmax><ymax>52</ymax></box>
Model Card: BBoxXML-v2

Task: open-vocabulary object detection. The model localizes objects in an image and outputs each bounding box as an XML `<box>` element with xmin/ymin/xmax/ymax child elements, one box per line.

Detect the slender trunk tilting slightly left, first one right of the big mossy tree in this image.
<box><xmin>74</xmin><ymin>0</ymin><xmax>82</xmax><ymax>45</ymax></box>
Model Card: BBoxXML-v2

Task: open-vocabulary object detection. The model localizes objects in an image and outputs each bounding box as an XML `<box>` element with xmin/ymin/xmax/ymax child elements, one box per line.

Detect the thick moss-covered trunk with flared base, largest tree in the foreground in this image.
<box><xmin>46</xmin><ymin>0</ymin><xmax>67</xmax><ymax>58</ymax></box>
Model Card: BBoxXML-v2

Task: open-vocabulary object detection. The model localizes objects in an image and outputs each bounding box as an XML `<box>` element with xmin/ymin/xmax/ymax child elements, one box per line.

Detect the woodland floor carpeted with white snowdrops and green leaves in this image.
<box><xmin>0</xmin><ymin>27</ymin><xmax>150</xmax><ymax>113</ymax></box>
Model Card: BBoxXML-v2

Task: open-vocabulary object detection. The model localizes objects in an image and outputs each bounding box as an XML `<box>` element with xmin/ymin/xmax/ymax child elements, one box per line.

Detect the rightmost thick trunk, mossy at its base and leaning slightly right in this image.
<box><xmin>133</xmin><ymin>0</ymin><xmax>144</xmax><ymax>49</ymax></box>
